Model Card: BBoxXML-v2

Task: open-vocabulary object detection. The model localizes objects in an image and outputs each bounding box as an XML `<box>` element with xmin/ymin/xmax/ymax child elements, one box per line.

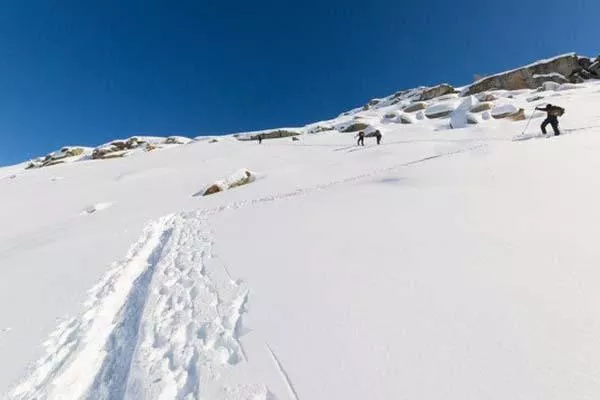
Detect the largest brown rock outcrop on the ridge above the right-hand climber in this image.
<box><xmin>462</xmin><ymin>54</ymin><xmax>592</xmax><ymax>96</ymax></box>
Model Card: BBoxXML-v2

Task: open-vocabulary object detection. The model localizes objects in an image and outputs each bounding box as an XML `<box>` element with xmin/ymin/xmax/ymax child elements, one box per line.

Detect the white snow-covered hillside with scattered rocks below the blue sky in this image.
<box><xmin>0</xmin><ymin>54</ymin><xmax>600</xmax><ymax>400</ymax></box>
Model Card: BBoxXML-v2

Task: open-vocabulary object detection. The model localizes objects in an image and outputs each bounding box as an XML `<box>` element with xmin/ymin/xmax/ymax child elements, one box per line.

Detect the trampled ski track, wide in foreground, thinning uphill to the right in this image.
<box><xmin>9</xmin><ymin>144</ymin><xmax>478</xmax><ymax>400</ymax></box>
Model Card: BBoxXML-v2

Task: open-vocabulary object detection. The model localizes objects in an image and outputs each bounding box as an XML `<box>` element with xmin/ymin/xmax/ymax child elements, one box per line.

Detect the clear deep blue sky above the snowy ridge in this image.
<box><xmin>0</xmin><ymin>0</ymin><xmax>600</xmax><ymax>165</ymax></box>
